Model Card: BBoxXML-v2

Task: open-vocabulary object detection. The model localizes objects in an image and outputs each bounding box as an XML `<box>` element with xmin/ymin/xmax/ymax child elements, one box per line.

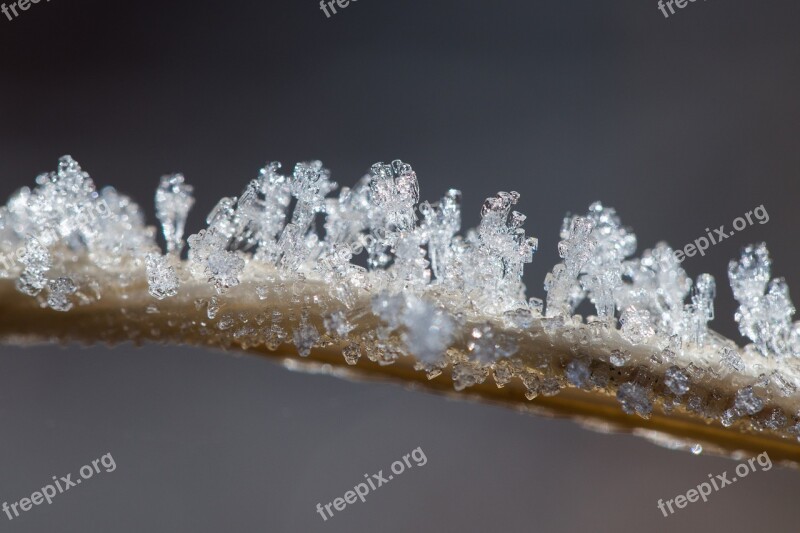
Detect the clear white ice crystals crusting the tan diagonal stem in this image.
<box><xmin>0</xmin><ymin>156</ymin><xmax>800</xmax><ymax>442</ymax></box>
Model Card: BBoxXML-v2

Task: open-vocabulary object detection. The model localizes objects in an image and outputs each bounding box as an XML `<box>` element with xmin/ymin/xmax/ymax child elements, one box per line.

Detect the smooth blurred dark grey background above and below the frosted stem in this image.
<box><xmin>0</xmin><ymin>0</ymin><xmax>800</xmax><ymax>533</ymax></box>
